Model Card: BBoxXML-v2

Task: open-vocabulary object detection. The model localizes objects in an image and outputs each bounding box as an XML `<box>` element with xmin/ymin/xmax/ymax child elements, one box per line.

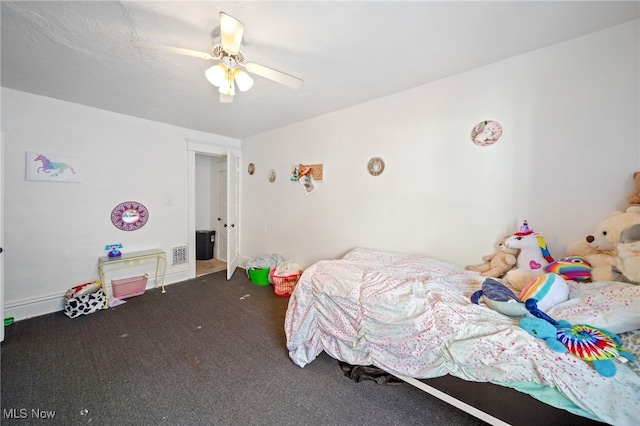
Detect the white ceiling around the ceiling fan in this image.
<box><xmin>1</xmin><ymin>1</ymin><xmax>640</xmax><ymax>139</ymax></box>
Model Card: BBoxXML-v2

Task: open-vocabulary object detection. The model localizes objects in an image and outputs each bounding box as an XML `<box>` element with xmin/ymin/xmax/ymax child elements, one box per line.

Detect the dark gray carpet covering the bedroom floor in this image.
<box><xmin>1</xmin><ymin>269</ymin><xmax>482</xmax><ymax>426</ymax></box>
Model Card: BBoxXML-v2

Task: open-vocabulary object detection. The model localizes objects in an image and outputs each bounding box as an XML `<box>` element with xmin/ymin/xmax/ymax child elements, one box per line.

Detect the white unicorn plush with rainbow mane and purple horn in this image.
<box><xmin>504</xmin><ymin>220</ymin><xmax>554</xmax><ymax>290</ymax></box>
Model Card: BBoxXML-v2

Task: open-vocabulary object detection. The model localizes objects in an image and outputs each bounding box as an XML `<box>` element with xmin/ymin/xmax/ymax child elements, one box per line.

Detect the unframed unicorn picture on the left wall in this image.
<box><xmin>26</xmin><ymin>152</ymin><xmax>80</xmax><ymax>182</ymax></box>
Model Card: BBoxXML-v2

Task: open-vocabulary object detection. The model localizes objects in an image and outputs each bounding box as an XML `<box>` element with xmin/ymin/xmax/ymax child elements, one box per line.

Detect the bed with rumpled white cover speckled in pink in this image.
<box><xmin>285</xmin><ymin>248</ymin><xmax>640</xmax><ymax>425</ymax></box>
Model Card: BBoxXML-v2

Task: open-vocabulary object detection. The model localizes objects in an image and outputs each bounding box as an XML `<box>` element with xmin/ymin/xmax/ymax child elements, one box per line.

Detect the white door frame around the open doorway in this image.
<box><xmin>187</xmin><ymin>139</ymin><xmax>240</xmax><ymax>278</ymax></box>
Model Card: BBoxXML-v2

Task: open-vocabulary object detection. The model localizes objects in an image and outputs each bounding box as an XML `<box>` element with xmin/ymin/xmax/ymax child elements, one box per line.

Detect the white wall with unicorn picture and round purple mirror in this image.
<box><xmin>1</xmin><ymin>89</ymin><xmax>240</xmax><ymax>319</ymax></box>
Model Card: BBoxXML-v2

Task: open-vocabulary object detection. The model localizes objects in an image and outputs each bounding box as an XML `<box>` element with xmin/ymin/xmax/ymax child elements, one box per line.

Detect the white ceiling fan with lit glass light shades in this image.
<box><xmin>131</xmin><ymin>12</ymin><xmax>303</xmax><ymax>103</ymax></box>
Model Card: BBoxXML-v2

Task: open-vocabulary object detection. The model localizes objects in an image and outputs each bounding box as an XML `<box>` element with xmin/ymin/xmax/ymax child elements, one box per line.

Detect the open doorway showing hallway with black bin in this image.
<box><xmin>195</xmin><ymin>154</ymin><xmax>227</xmax><ymax>277</ymax></box>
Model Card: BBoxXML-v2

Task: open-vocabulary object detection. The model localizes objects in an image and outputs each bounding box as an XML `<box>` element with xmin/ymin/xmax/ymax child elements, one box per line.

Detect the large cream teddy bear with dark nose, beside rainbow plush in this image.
<box><xmin>567</xmin><ymin>206</ymin><xmax>640</xmax><ymax>281</ymax></box>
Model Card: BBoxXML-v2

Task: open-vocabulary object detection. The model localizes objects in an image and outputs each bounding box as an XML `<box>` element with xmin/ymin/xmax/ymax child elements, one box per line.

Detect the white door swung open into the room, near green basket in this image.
<box><xmin>224</xmin><ymin>150</ymin><xmax>240</xmax><ymax>279</ymax></box>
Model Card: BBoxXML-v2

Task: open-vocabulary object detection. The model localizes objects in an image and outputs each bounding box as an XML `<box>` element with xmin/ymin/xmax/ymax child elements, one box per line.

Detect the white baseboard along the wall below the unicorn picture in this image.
<box><xmin>4</xmin><ymin>268</ymin><xmax>189</xmax><ymax>321</ymax></box>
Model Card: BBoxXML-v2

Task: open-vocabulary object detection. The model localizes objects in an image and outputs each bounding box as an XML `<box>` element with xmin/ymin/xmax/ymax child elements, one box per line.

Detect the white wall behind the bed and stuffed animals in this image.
<box><xmin>241</xmin><ymin>21</ymin><xmax>640</xmax><ymax>266</ymax></box>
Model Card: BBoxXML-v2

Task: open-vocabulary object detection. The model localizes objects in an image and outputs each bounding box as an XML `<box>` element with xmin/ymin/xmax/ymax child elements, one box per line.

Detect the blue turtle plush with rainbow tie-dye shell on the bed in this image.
<box><xmin>520</xmin><ymin>316</ymin><xmax>636</xmax><ymax>377</ymax></box>
